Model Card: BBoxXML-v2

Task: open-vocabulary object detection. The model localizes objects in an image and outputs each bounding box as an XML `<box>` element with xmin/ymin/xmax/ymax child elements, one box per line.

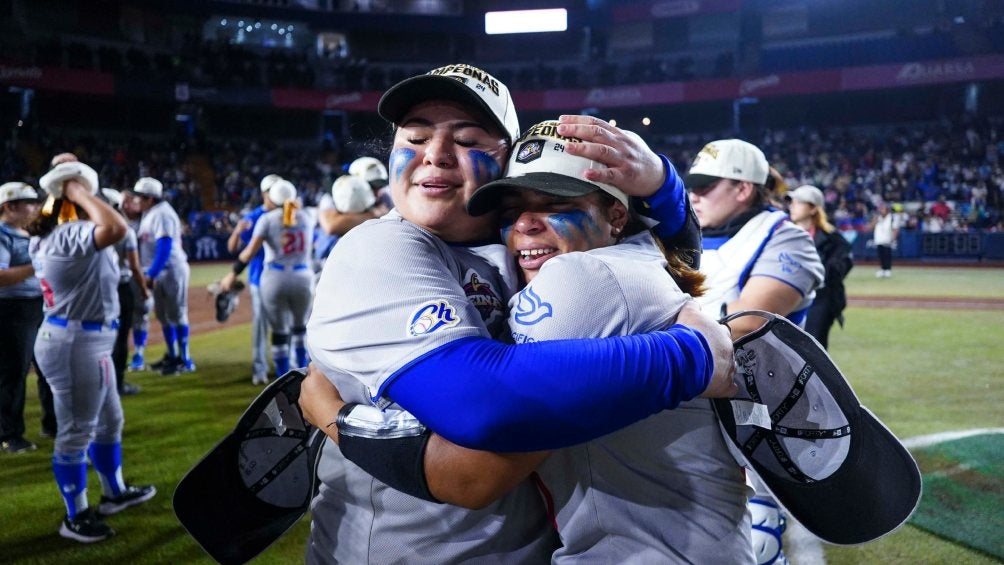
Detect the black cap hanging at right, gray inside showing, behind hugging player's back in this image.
<box><xmin>713</xmin><ymin>311</ymin><xmax>921</xmax><ymax>545</ymax></box>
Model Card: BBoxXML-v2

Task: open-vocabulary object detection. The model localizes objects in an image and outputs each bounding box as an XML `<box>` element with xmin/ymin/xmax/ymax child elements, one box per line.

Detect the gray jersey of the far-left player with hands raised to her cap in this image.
<box><xmin>32</xmin><ymin>221</ymin><xmax>118</xmax><ymax>323</ymax></box>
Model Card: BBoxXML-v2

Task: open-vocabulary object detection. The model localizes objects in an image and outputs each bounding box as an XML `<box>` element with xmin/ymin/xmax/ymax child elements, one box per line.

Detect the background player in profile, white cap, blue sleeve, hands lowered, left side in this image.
<box><xmin>133</xmin><ymin>177</ymin><xmax>195</xmax><ymax>375</ymax></box>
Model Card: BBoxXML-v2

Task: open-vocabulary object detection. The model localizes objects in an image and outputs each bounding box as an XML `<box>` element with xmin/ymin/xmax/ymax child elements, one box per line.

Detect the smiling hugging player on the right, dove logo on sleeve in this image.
<box><xmin>301</xmin><ymin>121</ymin><xmax>753</xmax><ymax>564</ymax></box>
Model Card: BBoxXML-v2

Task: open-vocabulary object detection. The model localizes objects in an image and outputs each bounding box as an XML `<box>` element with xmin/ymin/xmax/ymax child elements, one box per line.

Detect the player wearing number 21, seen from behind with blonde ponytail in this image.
<box><xmin>220</xmin><ymin>179</ymin><xmax>313</xmax><ymax>375</ymax></box>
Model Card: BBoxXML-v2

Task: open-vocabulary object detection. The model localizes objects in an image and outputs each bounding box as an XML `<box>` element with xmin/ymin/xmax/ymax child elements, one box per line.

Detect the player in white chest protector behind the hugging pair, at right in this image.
<box><xmin>685</xmin><ymin>139</ymin><xmax>823</xmax><ymax>563</ymax></box>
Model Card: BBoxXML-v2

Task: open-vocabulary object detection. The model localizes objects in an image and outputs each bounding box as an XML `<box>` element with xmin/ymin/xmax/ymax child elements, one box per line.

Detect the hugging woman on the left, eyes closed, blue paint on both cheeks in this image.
<box><xmin>300</xmin><ymin>65</ymin><xmax>731</xmax><ymax>563</ymax></box>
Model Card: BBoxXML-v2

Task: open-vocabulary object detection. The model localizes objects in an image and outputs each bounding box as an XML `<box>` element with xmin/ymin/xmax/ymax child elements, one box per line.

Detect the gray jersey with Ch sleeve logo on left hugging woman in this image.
<box><xmin>307</xmin><ymin>214</ymin><xmax>556</xmax><ymax>564</ymax></box>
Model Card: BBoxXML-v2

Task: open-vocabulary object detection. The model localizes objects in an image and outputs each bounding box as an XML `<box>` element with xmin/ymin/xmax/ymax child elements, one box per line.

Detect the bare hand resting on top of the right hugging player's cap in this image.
<box><xmin>558</xmin><ymin>115</ymin><xmax>666</xmax><ymax>198</ymax></box>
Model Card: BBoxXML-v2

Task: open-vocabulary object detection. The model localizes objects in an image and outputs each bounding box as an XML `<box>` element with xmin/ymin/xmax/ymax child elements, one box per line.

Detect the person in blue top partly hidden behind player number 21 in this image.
<box><xmin>227</xmin><ymin>174</ymin><xmax>282</xmax><ymax>384</ymax></box>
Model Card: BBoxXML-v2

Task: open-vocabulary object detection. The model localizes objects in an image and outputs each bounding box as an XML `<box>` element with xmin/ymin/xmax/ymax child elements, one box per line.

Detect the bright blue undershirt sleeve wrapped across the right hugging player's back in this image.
<box><xmin>385</xmin><ymin>324</ymin><xmax>714</xmax><ymax>452</ymax></box>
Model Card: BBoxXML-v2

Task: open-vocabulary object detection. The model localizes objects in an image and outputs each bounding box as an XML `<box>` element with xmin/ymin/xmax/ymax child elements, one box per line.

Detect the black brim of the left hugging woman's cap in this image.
<box><xmin>377</xmin><ymin>74</ymin><xmax>513</xmax><ymax>143</ymax></box>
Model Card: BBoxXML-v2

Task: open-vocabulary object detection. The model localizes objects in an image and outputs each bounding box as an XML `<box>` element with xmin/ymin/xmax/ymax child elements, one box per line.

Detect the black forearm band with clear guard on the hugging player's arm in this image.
<box><xmin>335</xmin><ymin>402</ymin><xmax>440</xmax><ymax>503</ymax></box>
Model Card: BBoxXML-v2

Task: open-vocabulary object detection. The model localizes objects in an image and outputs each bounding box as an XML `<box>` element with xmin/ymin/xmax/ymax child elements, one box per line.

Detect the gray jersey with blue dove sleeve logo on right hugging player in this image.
<box><xmin>509</xmin><ymin>233</ymin><xmax>753</xmax><ymax>563</ymax></box>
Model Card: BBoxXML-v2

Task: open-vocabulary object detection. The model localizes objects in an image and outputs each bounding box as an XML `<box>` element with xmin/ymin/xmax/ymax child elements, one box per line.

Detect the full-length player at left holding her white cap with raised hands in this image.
<box><xmin>31</xmin><ymin>162</ymin><xmax>157</xmax><ymax>543</ymax></box>
